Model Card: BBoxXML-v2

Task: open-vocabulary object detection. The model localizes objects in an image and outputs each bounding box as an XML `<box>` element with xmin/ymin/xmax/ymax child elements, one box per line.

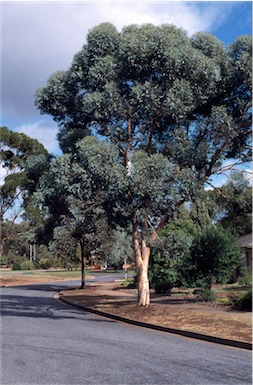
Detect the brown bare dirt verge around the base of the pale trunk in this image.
<box><xmin>61</xmin><ymin>283</ymin><xmax>252</xmax><ymax>343</ymax></box>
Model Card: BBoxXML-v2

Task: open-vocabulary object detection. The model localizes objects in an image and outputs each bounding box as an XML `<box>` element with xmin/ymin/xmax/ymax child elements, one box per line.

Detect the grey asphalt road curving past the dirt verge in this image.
<box><xmin>0</xmin><ymin>274</ymin><xmax>252</xmax><ymax>385</ymax></box>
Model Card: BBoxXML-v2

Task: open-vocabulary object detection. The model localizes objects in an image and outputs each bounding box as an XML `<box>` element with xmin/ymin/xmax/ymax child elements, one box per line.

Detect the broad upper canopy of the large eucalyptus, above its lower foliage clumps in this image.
<box><xmin>36</xmin><ymin>23</ymin><xmax>251</xmax><ymax>165</ymax></box>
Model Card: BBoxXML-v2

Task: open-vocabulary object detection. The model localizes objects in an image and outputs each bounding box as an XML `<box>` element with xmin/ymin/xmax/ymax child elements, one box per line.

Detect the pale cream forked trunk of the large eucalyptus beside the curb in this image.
<box><xmin>133</xmin><ymin>222</ymin><xmax>150</xmax><ymax>306</ymax></box>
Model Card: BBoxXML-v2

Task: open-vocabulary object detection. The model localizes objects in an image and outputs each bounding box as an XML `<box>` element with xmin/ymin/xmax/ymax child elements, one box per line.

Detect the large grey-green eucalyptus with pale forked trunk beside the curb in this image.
<box><xmin>35</xmin><ymin>23</ymin><xmax>252</xmax><ymax>305</ymax></box>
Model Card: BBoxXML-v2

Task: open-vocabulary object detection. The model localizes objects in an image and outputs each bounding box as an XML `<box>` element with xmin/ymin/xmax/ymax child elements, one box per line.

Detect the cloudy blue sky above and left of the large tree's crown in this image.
<box><xmin>0</xmin><ymin>1</ymin><xmax>252</xmax><ymax>185</ymax></box>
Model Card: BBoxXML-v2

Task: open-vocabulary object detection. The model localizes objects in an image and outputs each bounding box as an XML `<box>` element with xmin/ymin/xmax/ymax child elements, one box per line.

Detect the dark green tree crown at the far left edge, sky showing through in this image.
<box><xmin>0</xmin><ymin>127</ymin><xmax>51</xmax><ymax>253</ymax></box>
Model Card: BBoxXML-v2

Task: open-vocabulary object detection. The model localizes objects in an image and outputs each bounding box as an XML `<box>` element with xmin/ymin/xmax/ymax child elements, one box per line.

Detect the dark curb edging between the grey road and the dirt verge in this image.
<box><xmin>57</xmin><ymin>293</ymin><xmax>252</xmax><ymax>350</ymax></box>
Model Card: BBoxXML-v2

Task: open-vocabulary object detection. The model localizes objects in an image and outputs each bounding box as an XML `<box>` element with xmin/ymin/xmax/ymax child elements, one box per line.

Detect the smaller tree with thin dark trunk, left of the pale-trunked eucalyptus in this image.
<box><xmin>36</xmin><ymin>137</ymin><xmax>111</xmax><ymax>287</ymax></box>
